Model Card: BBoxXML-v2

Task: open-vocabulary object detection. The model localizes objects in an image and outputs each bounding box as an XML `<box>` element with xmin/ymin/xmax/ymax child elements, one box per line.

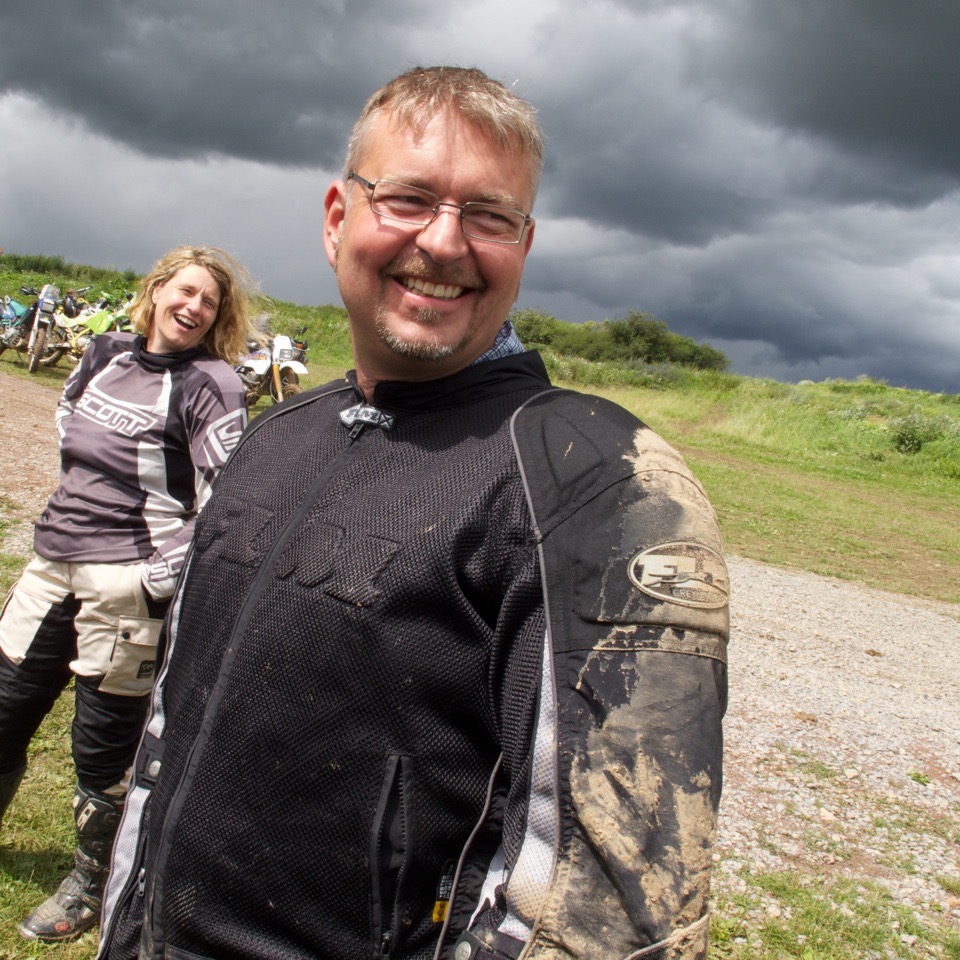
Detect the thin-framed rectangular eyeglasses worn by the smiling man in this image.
<box><xmin>347</xmin><ymin>170</ymin><xmax>531</xmax><ymax>243</ymax></box>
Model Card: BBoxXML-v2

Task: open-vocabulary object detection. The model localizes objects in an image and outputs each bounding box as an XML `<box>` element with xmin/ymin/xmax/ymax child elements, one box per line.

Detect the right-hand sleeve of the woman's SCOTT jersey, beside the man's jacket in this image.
<box><xmin>141</xmin><ymin>364</ymin><xmax>247</xmax><ymax>600</ymax></box>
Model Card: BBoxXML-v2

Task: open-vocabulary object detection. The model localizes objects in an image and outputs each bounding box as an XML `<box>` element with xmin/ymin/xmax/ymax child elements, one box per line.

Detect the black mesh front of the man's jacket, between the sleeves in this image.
<box><xmin>105</xmin><ymin>359</ymin><xmax>548</xmax><ymax>958</ymax></box>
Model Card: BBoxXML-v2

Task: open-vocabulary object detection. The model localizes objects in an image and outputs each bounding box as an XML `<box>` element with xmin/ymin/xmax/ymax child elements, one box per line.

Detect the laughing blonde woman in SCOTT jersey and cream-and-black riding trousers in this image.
<box><xmin>0</xmin><ymin>247</ymin><xmax>248</xmax><ymax>941</ymax></box>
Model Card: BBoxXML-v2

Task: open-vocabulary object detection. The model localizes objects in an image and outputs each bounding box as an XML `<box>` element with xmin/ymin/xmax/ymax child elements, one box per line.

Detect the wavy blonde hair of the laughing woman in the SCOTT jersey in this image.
<box><xmin>129</xmin><ymin>245</ymin><xmax>255</xmax><ymax>366</ymax></box>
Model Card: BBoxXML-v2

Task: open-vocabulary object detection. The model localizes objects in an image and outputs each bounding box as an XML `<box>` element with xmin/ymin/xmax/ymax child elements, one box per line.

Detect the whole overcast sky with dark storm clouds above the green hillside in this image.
<box><xmin>0</xmin><ymin>0</ymin><xmax>960</xmax><ymax>393</ymax></box>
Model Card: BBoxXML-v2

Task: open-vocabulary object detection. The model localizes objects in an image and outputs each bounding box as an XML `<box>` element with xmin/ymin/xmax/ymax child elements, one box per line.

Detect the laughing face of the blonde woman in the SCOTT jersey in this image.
<box><xmin>147</xmin><ymin>263</ymin><xmax>220</xmax><ymax>353</ymax></box>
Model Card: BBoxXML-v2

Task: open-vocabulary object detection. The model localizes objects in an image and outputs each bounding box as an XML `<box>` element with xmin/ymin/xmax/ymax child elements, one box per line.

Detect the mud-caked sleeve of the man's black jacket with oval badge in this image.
<box><xmin>462</xmin><ymin>395</ymin><xmax>729</xmax><ymax>960</ymax></box>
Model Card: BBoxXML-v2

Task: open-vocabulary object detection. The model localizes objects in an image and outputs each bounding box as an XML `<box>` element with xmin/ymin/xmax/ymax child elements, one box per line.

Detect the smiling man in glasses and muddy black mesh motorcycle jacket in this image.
<box><xmin>100</xmin><ymin>67</ymin><xmax>728</xmax><ymax>960</ymax></box>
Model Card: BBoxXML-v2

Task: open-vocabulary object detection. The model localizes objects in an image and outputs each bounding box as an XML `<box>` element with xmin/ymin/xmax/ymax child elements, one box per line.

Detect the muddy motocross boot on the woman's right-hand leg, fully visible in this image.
<box><xmin>17</xmin><ymin>784</ymin><xmax>123</xmax><ymax>943</ymax></box>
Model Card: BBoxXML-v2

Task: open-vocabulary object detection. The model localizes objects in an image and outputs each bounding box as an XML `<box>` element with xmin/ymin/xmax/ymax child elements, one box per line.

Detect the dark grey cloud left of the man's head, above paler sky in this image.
<box><xmin>0</xmin><ymin>0</ymin><xmax>425</xmax><ymax>165</ymax></box>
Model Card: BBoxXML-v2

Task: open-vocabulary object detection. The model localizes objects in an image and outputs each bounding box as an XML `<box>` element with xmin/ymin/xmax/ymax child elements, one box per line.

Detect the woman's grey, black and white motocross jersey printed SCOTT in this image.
<box><xmin>34</xmin><ymin>333</ymin><xmax>247</xmax><ymax>598</ymax></box>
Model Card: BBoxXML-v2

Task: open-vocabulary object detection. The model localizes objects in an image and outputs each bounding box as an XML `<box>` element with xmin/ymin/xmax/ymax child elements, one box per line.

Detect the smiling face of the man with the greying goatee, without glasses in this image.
<box><xmin>324</xmin><ymin>111</ymin><xmax>533</xmax><ymax>383</ymax></box>
